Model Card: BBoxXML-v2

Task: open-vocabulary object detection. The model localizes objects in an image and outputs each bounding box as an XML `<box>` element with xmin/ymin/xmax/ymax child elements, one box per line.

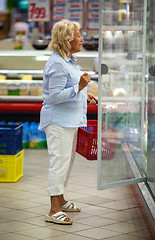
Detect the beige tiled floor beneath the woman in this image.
<box><xmin>0</xmin><ymin>150</ymin><xmax>152</xmax><ymax>240</ymax></box>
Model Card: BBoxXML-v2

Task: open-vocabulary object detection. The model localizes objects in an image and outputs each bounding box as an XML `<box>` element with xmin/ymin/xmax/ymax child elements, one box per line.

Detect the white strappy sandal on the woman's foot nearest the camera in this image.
<box><xmin>45</xmin><ymin>212</ymin><xmax>73</xmax><ymax>225</ymax></box>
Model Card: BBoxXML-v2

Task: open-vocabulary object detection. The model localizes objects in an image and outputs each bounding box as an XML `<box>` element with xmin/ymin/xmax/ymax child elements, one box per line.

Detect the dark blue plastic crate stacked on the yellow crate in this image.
<box><xmin>0</xmin><ymin>124</ymin><xmax>23</xmax><ymax>155</ymax></box>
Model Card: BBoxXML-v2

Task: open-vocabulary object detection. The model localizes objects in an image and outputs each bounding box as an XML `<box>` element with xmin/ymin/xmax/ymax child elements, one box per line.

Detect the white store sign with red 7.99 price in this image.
<box><xmin>28</xmin><ymin>0</ymin><xmax>50</xmax><ymax>22</ymax></box>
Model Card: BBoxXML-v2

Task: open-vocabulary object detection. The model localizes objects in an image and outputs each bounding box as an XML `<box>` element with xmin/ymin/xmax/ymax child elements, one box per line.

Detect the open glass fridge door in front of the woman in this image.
<box><xmin>98</xmin><ymin>0</ymin><xmax>147</xmax><ymax>189</ymax></box>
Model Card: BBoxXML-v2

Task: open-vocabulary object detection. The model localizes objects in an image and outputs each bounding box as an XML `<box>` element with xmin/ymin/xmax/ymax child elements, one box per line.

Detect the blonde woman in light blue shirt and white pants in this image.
<box><xmin>39</xmin><ymin>20</ymin><xmax>96</xmax><ymax>224</ymax></box>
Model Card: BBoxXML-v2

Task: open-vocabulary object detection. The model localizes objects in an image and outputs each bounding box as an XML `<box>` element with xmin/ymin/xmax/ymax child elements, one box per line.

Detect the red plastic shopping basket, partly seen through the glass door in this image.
<box><xmin>76</xmin><ymin>120</ymin><xmax>118</xmax><ymax>160</ymax></box>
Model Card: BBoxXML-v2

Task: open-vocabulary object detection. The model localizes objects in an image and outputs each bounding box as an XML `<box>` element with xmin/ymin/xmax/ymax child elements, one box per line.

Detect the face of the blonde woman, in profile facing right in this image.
<box><xmin>70</xmin><ymin>29</ymin><xmax>83</xmax><ymax>54</ymax></box>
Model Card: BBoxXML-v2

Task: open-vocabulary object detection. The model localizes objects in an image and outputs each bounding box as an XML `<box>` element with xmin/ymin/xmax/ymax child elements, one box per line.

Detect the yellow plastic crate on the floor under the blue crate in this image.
<box><xmin>0</xmin><ymin>150</ymin><xmax>24</xmax><ymax>182</ymax></box>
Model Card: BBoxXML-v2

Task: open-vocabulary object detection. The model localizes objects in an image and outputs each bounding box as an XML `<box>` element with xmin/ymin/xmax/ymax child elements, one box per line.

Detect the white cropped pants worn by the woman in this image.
<box><xmin>44</xmin><ymin>124</ymin><xmax>78</xmax><ymax>196</ymax></box>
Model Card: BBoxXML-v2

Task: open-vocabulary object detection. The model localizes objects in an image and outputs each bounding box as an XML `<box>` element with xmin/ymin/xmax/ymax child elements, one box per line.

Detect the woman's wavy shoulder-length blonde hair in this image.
<box><xmin>49</xmin><ymin>19</ymin><xmax>80</xmax><ymax>58</ymax></box>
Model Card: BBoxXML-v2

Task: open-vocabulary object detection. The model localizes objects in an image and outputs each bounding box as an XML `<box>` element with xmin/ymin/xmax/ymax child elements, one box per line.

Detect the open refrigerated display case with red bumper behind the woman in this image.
<box><xmin>0</xmin><ymin>50</ymin><xmax>98</xmax><ymax>122</ymax></box>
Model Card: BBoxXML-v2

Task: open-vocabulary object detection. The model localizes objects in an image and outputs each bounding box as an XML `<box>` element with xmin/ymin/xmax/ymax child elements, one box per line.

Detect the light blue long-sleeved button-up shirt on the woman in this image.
<box><xmin>39</xmin><ymin>51</ymin><xmax>87</xmax><ymax>130</ymax></box>
